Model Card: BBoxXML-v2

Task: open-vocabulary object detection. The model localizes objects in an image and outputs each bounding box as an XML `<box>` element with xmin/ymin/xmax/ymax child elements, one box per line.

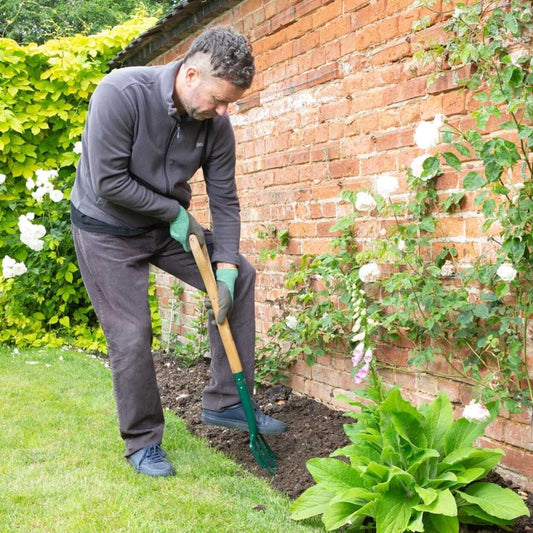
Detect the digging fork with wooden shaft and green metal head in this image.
<box><xmin>189</xmin><ymin>235</ymin><xmax>278</xmax><ymax>475</ymax></box>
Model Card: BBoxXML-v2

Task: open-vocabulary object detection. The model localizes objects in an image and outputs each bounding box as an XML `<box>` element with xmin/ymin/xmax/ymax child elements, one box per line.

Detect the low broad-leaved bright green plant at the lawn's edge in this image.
<box><xmin>291</xmin><ymin>371</ymin><xmax>529</xmax><ymax>533</ymax></box>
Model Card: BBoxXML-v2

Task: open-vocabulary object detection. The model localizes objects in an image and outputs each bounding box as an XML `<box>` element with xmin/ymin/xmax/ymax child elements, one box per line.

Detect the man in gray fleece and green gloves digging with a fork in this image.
<box><xmin>71</xmin><ymin>26</ymin><xmax>286</xmax><ymax>476</ymax></box>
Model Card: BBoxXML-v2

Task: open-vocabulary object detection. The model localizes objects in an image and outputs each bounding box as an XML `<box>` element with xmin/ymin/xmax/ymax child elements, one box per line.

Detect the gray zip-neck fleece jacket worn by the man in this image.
<box><xmin>71</xmin><ymin>61</ymin><xmax>240</xmax><ymax>264</ymax></box>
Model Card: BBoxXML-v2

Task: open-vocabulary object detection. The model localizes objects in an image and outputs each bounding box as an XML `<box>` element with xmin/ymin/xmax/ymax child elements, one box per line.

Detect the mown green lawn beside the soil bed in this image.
<box><xmin>0</xmin><ymin>348</ymin><xmax>323</xmax><ymax>533</ymax></box>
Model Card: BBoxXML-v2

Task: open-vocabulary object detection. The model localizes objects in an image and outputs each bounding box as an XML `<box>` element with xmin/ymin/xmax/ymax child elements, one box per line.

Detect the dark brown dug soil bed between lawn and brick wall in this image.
<box><xmin>154</xmin><ymin>353</ymin><xmax>533</xmax><ymax>533</ymax></box>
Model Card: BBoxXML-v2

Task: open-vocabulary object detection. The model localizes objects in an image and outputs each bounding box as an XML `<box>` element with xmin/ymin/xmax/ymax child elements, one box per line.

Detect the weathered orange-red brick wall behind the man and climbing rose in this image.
<box><xmin>150</xmin><ymin>0</ymin><xmax>533</xmax><ymax>489</ymax></box>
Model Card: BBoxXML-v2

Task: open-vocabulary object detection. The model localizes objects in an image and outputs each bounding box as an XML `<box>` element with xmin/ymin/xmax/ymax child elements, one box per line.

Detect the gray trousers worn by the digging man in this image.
<box><xmin>72</xmin><ymin>222</ymin><xmax>255</xmax><ymax>456</ymax></box>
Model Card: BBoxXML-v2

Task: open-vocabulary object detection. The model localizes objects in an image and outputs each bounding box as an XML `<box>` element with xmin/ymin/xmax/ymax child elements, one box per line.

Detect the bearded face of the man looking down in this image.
<box><xmin>179</xmin><ymin>67</ymin><xmax>245</xmax><ymax>120</ymax></box>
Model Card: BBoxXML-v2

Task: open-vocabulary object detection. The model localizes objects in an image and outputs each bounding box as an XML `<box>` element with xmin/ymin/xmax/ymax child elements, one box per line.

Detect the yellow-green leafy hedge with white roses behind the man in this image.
<box><xmin>0</xmin><ymin>17</ymin><xmax>154</xmax><ymax>350</ymax></box>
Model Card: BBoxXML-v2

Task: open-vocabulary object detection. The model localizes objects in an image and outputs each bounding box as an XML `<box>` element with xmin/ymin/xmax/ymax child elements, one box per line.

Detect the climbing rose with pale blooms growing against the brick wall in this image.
<box><xmin>256</xmin><ymin>0</ymin><xmax>533</xmax><ymax>412</ymax></box>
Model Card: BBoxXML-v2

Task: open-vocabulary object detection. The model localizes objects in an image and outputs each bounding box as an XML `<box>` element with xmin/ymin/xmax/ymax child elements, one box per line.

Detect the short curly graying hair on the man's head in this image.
<box><xmin>184</xmin><ymin>26</ymin><xmax>255</xmax><ymax>89</ymax></box>
